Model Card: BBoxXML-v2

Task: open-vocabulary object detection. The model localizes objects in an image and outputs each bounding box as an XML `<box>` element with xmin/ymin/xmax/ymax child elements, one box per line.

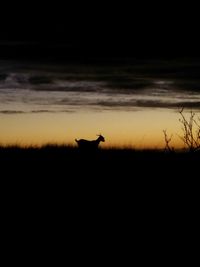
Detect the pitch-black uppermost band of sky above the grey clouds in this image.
<box><xmin>0</xmin><ymin>1</ymin><xmax>199</xmax><ymax>58</ymax></box>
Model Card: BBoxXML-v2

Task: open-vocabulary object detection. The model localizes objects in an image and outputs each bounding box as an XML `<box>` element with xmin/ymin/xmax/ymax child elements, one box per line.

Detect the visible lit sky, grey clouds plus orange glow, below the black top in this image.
<box><xmin>0</xmin><ymin>58</ymin><xmax>200</xmax><ymax>148</ymax></box>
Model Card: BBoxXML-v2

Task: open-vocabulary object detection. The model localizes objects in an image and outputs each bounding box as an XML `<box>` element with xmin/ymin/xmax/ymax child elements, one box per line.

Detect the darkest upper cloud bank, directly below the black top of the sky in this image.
<box><xmin>0</xmin><ymin>59</ymin><xmax>200</xmax><ymax>93</ymax></box>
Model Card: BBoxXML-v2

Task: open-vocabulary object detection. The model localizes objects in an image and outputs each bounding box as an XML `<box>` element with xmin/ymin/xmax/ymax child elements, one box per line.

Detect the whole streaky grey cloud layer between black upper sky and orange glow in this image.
<box><xmin>0</xmin><ymin>59</ymin><xmax>200</xmax><ymax>114</ymax></box>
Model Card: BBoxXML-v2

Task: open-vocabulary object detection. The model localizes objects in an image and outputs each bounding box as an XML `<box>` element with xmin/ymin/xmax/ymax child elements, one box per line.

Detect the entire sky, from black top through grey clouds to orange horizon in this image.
<box><xmin>0</xmin><ymin>4</ymin><xmax>200</xmax><ymax>148</ymax></box>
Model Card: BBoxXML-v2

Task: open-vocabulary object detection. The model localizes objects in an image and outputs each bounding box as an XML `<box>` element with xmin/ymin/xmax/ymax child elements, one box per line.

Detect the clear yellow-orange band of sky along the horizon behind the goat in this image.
<box><xmin>0</xmin><ymin>109</ymin><xmax>183</xmax><ymax>149</ymax></box>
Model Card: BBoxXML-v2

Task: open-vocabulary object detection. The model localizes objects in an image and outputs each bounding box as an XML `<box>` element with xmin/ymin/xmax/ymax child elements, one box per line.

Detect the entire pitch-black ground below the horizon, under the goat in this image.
<box><xmin>0</xmin><ymin>146</ymin><xmax>200</xmax><ymax>263</ymax></box>
